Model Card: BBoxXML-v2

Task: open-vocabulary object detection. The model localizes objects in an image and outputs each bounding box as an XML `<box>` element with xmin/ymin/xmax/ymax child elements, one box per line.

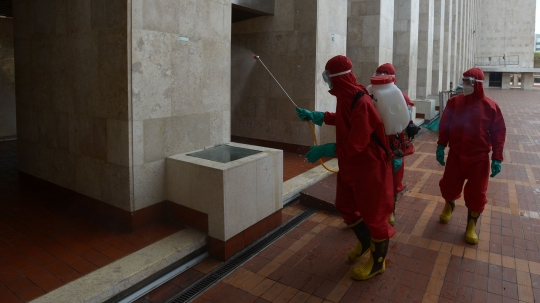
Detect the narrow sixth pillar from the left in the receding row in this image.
<box><xmin>431</xmin><ymin>0</ymin><xmax>446</xmax><ymax>95</ymax></box>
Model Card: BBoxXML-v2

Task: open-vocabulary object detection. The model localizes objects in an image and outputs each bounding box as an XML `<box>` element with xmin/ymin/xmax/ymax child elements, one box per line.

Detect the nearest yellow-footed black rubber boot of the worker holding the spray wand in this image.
<box><xmin>351</xmin><ymin>239</ymin><xmax>390</xmax><ymax>280</ymax></box>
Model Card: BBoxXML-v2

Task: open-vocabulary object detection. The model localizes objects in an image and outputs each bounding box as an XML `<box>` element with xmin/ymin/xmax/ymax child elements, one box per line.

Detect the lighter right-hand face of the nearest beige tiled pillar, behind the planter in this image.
<box><xmin>130</xmin><ymin>0</ymin><xmax>231</xmax><ymax>210</ymax></box>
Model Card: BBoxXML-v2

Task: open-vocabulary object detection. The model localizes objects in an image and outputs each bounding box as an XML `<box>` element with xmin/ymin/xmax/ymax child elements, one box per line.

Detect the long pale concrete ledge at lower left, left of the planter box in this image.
<box><xmin>31</xmin><ymin>228</ymin><xmax>207</xmax><ymax>303</ymax></box>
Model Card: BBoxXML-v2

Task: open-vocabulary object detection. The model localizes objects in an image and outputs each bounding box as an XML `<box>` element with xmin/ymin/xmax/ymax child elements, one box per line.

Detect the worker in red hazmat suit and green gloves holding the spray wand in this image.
<box><xmin>297</xmin><ymin>56</ymin><xmax>395</xmax><ymax>280</ymax></box>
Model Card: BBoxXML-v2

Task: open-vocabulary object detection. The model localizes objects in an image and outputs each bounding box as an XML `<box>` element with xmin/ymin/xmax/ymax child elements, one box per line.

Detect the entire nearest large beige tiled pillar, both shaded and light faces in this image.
<box><xmin>15</xmin><ymin>0</ymin><xmax>231</xmax><ymax>211</ymax></box>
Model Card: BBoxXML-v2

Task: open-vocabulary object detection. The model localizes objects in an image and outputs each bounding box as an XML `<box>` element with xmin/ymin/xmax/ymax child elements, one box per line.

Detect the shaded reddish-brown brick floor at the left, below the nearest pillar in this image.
<box><xmin>0</xmin><ymin>141</ymin><xmax>182</xmax><ymax>303</ymax></box>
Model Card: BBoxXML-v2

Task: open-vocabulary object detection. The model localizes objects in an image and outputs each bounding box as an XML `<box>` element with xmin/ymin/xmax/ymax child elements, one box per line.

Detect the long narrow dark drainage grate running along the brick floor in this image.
<box><xmin>167</xmin><ymin>208</ymin><xmax>317</xmax><ymax>303</ymax></box>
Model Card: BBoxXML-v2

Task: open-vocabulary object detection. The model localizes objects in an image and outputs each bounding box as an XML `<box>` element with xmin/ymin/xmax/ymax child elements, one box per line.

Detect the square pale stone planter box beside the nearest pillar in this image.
<box><xmin>166</xmin><ymin>143</ymin><xmax>283</xmax><ymax>241</ymax></box>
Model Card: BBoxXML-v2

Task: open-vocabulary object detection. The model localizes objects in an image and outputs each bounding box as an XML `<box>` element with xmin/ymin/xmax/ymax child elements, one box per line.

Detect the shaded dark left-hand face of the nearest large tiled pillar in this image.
<box><xmin>13</xmin><ymin>0</ymin><xmax>132</xmax><ymax>211</ymax></box>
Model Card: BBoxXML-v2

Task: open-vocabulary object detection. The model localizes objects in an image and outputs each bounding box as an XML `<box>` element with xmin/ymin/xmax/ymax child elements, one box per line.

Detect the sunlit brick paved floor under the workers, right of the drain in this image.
<box><xmin>190</xmin><ymin>89</ymin><xmax>540</xmax><ymax>303</ymax></box>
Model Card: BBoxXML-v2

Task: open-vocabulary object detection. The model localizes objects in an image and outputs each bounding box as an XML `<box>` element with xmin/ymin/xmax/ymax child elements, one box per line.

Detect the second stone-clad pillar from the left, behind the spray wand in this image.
<box><xmin>231</xmin><ymin>0</ymin><xmax>347</xmax><ymax>145</ymax></box>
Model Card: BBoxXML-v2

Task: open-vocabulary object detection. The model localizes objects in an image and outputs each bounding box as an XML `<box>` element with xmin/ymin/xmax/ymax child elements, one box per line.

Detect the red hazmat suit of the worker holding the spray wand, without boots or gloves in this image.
<box><xmin>324</xmin><ymin>56</ymin><xmax>395</xmax><ymax>239</ymax></box>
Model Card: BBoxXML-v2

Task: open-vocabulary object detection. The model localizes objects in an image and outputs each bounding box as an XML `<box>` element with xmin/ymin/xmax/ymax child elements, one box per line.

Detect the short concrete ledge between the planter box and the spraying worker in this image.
<box><xmin>283</xmin><ymin>159</ymin><xmax>339</xmax><ymax>201</ymax></box>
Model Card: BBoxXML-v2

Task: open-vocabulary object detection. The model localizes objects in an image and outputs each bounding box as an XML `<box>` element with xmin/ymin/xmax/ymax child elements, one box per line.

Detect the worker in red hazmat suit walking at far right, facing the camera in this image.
<box><xmin>436</xmin><ymin>68</ymin><xmax>506</xmax><ymax>244</ymax></box>
